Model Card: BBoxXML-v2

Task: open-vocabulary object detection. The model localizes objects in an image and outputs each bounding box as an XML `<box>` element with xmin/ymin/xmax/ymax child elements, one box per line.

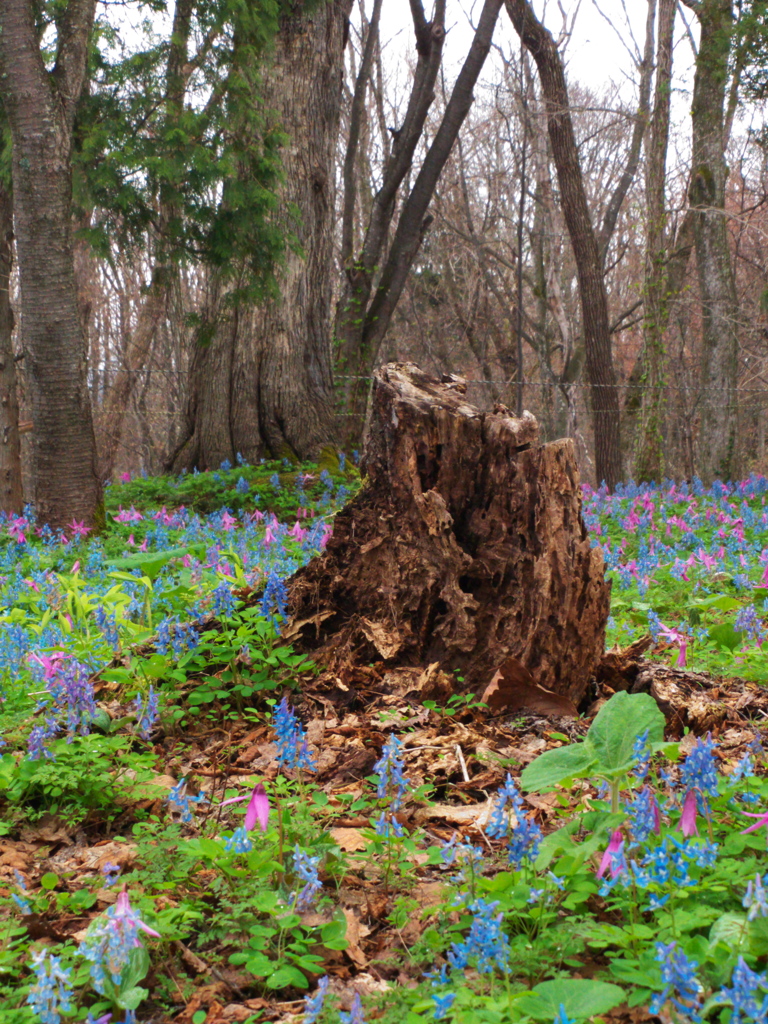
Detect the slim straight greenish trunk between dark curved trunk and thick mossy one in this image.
<box><xmin>635</xmin><ymin>0</ymin><xmax>677</xmax><ymax>481</ymax></box>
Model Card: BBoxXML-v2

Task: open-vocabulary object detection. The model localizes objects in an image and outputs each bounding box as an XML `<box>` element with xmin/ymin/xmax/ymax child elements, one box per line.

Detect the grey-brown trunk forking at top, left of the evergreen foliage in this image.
<box><xmin>0</xmin><ymin>0</ymin><xmax>101</xmax><ymax>527</ymax></box>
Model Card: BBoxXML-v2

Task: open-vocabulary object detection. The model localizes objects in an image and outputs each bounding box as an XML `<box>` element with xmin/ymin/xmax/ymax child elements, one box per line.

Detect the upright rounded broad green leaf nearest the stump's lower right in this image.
<box><xmin>587</xmin><ymin>691</ymin><xmax>665</xmax><ymax>772</ymax></box>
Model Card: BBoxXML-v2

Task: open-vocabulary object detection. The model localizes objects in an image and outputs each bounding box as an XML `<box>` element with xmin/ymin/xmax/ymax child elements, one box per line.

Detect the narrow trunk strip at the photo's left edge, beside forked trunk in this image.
<box><xmin>0</xmin><ymin>185</ymin><xmax>24</xmax><ymax>513</ymax></box>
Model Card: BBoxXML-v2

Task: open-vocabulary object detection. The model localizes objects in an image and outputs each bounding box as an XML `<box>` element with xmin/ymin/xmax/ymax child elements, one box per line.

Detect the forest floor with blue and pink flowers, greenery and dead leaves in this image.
<box><xmin>0</xmin><ymin>461</ymin><xmax>768</xmax><ymax>1024</ymax></box>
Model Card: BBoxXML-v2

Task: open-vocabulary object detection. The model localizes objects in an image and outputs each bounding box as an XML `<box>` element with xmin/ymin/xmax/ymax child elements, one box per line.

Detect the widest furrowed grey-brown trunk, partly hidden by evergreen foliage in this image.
<box><xmin>171</xmin><ymin>0</ymin><xmax>350</xmax><ymax>472</ymax></box>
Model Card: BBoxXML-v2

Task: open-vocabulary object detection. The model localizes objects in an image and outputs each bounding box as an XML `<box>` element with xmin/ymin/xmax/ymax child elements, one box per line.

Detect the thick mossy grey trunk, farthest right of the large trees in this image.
<box><xmin>689</xmin><ymin>0</ymin><xmax>739</xmax><ymax>483</ymax></box>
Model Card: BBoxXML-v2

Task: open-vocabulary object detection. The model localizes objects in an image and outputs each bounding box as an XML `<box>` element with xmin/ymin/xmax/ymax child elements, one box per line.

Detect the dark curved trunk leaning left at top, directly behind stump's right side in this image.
<box><xmin>505</xmin><ymin>0</ymin><xmax>626</xmax><ymax>487</ymax></box>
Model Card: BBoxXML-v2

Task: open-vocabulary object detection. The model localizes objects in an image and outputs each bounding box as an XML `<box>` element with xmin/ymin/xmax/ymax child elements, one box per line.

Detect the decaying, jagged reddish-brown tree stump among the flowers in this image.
<box><xmin>287</xmin><ymin>364</ymin><xmax>609</xmax><ymax>702</ymax></box>
